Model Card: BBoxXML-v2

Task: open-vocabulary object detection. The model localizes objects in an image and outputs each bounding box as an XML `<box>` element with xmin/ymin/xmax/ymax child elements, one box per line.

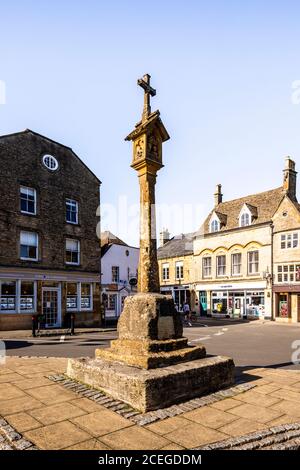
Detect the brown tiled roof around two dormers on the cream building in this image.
<box><xmin>200</xmin><ymin>187</ymin><xmax>285</xmax><ymax>236</ymax></box>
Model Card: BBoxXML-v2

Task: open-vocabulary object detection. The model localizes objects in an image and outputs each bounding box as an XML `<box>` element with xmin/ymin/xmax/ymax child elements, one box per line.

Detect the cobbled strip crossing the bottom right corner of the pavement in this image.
<box><xmin>194</xmin><ymin>423</ymin><xmax>300</xmax><ymax>450</ymax></box>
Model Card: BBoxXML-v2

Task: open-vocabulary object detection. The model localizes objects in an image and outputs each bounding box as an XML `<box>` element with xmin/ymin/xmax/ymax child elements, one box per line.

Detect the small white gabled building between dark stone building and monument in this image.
<box><xmin>101</xmin><ymin>231</ymin><xmax>139</xmax><ymax>321</ymax></box>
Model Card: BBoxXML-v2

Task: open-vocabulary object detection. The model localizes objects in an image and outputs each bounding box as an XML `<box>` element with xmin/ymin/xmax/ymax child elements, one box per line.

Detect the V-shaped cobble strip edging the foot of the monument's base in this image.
<box><xmin>48</xmin><ymin>375</ymin><xmax>256</xmax><ymax>426</ymax></box>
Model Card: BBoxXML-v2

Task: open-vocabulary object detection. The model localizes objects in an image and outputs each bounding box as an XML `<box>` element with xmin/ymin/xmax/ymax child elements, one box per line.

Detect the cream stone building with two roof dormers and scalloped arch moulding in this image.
<box><xmin>194</xmin><ymin>185</ymin><xmax>276</xmax><ymax>318</ymax></box>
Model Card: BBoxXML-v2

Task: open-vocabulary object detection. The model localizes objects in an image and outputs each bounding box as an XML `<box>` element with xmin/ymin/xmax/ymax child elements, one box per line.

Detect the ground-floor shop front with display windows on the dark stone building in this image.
<box><xmin>0</xmin><ymin>270</ymin><xmax>100</xmax><ymax>330</ymax></box>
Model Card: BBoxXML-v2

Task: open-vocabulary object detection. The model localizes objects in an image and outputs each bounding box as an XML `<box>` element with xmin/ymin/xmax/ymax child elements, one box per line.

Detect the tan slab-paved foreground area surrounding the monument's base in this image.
<box><xmin>0</xmin><ymin>357</ymin><xmax>300</xmax><ymax>451</ymax></box>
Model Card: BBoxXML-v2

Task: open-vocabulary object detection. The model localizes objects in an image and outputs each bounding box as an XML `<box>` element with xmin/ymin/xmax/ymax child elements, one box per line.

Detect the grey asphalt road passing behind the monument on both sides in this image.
<box><xmin>1</xmin><ymin>319</ymin><xmax>300</xmax><ymax>370</ymax></box>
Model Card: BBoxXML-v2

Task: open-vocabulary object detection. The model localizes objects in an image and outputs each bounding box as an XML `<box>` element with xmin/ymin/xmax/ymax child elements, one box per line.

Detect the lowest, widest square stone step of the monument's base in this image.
<box><xmin>67</xmin><ymin>356</ymin><xmax>234</xmax><ymax>412</ymax></box>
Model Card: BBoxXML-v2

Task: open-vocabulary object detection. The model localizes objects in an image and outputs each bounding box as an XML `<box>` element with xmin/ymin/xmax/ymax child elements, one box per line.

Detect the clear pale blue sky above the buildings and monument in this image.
<box><xmin>0</xmin><ymin>0</ymin><xmax>300</xmax><ymax>243</ymax></box>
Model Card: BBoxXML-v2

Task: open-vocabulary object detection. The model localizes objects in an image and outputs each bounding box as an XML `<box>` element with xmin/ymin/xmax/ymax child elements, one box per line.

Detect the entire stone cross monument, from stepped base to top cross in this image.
<box><xmin>67</xmin><ymin>74</ymin><xmax>234</xmax><ymax>411</ymax></box>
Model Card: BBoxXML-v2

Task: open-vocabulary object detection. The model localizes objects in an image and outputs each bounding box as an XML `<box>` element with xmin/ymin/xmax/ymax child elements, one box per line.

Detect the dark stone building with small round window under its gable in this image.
<box><xmin>0</xmin><ymin>130</ymin><xmax>100</xmax><ymax>330</ymax></box>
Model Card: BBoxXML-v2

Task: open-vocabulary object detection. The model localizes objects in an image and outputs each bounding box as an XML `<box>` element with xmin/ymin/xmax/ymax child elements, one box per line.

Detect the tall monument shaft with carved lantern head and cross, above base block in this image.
<box><xmin>126</xmin><ymin>74</ymin><xmax>169</xmax><ymax>293</ymax></box>
